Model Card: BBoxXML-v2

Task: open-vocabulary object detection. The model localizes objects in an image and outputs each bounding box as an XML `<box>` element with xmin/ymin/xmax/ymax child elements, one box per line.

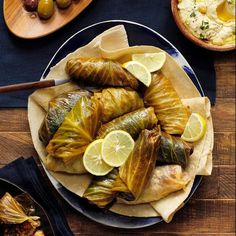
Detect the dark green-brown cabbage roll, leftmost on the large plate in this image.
<box><xmin>39</xmin><ymin>89</ymin><xmax>90</xmax><ymax>145</ymax></box>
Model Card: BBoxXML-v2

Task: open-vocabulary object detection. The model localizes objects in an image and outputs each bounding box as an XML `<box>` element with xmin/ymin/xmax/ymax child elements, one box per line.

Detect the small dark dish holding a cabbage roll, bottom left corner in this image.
<box><xmin>0</xmin><ymin>178</ymin><xmax>55</xmax><ymax>236</ymax></box>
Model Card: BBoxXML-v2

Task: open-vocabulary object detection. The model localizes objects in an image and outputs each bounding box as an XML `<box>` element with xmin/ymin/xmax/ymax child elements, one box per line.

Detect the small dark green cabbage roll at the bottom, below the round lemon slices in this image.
<box><xmin>83</xmin><ymin>168</ymin><xmax>118</xmax><ymax>208</ymax></box>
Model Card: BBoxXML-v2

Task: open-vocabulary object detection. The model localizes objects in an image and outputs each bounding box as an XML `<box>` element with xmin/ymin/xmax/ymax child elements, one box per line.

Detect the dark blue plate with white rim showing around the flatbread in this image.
<box><xmin>42</xmin><ymin>20</ymin><xmax>204</xmax><ymax>229</ymax></box>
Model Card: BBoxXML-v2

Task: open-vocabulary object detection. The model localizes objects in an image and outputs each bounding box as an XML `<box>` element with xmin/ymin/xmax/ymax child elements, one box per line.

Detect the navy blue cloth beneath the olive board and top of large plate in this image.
<box><xmin>0</xmin><ymin>0</ymin><xmax>216</xmax><ymax>107</ymax></box>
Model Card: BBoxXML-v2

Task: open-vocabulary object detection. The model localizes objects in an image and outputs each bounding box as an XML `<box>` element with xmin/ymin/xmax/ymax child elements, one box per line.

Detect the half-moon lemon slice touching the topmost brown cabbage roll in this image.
<box><xmin>122</xmin><ymin>61</ymin><xmax>152</xmax><ymax>87</ymax></box>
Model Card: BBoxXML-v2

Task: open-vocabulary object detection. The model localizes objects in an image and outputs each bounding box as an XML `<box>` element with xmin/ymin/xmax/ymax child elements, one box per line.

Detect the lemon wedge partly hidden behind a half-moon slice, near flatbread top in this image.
<box><xmin>132</xmin><ymin>52</ymin><xmax>166</xmax><ymax>72</ymax></box>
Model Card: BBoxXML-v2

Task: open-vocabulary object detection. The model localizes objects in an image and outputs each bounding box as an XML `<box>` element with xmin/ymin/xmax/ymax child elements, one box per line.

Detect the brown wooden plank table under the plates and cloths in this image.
<box><xmin>0</xmin><ymin>52</ymin><xmax>235</xmax><ymax>235</ymax></box>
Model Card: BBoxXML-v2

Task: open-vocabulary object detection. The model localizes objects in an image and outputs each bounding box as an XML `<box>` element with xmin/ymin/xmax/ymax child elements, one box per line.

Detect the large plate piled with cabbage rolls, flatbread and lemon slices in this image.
<box><xmin>28</xmin><ymin>20</ymin><xmax>214</xmax><ymax>228</ymax></box>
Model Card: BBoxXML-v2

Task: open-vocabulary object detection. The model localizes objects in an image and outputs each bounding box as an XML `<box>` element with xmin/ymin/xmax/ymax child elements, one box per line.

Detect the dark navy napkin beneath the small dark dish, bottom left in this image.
<box><xmin>0</xmin><ymin>157</ymin><xmax>73</xmax><ymax>236</ymax></box>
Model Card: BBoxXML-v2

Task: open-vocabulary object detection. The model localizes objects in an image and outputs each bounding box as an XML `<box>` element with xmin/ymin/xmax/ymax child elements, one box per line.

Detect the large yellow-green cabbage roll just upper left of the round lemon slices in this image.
<box><xmin>46</xmin><ymin>97</ymin><xmax>101</xmax><ymax>162</ymax></box>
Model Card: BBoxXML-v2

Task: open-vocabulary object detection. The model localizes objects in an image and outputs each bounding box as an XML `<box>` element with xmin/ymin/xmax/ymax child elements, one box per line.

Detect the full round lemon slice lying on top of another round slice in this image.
<box><xmin>102</xmin><ymin>130</ymin><xmax>134</xmax><ymax>167</ymax></box>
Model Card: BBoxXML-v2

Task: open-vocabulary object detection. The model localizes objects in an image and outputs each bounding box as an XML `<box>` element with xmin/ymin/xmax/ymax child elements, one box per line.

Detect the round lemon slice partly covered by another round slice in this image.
<box><xmin>83</xmin><ymin>139</ymin><xmax>113</xmax><ymax>176</ymax></box>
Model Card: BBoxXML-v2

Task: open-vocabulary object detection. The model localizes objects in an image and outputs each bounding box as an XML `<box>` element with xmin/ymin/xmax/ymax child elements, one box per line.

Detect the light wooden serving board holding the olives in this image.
<box><xmin>3</xmin><ymin>0</ymin><xmax>92</xmax><ymax>39</ymax></box>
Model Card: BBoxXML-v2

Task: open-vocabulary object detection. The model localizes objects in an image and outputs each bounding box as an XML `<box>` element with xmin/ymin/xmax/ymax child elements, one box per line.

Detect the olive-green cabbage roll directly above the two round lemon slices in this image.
<box><xmin>97</xmin><ymin>107</ymin><xmax>157</xmax><ymax>138</ymax></box>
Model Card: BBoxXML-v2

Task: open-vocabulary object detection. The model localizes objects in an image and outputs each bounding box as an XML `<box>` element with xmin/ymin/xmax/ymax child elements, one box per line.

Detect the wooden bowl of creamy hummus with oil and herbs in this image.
<box><xmin>171</xmin><ymin>0</ymin><xmax>235</xmax><ymax>51</ymax></box>
